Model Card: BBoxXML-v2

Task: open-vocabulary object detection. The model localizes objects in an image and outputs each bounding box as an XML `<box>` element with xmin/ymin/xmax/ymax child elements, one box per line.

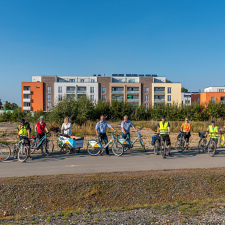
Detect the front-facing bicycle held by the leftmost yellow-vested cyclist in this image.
<box><xmin>13</xmin><ymin>137</ymin><xmax>29</xmax><ymax>162</ymax></box>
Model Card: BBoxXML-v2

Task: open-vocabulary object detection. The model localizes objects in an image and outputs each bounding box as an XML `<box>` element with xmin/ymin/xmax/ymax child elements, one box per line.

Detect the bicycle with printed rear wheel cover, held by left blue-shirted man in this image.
<box><xmin>87</xmin><ymin>131</ymin><xmax>124</xmax><ymax>156</ymax></box>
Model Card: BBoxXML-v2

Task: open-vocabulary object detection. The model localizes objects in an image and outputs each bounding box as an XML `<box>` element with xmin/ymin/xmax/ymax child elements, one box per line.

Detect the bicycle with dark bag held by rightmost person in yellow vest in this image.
<box><xmin>198</xmin><ymin>131</ymin><xmax>216</xmax><ymax>157</ymax></box>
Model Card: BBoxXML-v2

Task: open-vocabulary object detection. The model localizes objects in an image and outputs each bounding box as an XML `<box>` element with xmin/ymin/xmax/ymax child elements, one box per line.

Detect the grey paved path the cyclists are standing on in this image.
<box><xmin>0</xmin><ymin>149</ymin><xmax>225</xmax><ymax>177</ymax></box>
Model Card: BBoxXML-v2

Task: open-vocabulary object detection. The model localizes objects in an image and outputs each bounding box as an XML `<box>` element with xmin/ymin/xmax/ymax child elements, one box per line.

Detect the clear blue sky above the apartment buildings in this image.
<box><xmin>0</xmin><ymin>0</ymin><xmax>225</xmax><ymax>105</ymax></box>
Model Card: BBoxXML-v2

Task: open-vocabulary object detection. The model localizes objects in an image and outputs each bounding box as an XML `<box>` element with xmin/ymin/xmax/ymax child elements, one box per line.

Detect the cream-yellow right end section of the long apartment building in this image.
<box><xmin>152</xmin><ymin>83</ymin><xmax>181</xmax><ymax>106</ymax></box>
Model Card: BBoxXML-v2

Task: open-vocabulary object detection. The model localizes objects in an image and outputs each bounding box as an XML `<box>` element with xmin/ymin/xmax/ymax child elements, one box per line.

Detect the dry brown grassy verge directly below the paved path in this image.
<box><xmin>0</xmin><ymin>168</ymin><xmax>225</xmax><ymax>219</ymax></box>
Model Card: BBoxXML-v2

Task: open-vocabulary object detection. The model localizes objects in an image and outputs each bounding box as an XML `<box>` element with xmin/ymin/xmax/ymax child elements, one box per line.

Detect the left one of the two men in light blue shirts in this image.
<box><xmin>95</xmin><ymin>115</ymin><xmax>116</xmax><ymax>155</ymax></box>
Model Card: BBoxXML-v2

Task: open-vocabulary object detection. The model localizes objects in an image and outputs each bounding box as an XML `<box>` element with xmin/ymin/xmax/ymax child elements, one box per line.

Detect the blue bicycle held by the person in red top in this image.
<box><xmin>30</xmin><ymin>132</ymin><xmax>54</xmax><ymax>155</ymax></box>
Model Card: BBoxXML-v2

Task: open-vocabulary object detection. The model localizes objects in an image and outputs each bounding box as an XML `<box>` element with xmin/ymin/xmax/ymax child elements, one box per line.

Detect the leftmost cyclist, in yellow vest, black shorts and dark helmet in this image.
<box><xmin>17</xmin><ymin>119</ymin><xmax>32</xmax><ymax>160</ymax></box>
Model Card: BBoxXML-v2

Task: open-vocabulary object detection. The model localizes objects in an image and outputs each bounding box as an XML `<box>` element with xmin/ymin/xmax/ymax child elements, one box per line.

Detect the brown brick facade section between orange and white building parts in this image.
<box><xmin>42</xmin><ymin>76</ymin><xmax>56</xmax><ymax>111</ymax></box>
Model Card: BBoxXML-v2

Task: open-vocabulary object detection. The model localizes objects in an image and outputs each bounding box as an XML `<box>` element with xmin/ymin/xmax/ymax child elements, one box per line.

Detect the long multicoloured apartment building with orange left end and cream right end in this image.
<box><xmin>22</xmin><ymin>74</ymin><xmax>181</xmax><ymax>111</ymax></box>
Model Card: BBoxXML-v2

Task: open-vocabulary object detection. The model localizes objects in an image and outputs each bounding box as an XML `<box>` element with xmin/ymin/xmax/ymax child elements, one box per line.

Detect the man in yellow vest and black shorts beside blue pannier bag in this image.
<box><xmin>157</xmin><ymin>115</ymin><xmax>172</xmax><ymax>157</ymax></box>
